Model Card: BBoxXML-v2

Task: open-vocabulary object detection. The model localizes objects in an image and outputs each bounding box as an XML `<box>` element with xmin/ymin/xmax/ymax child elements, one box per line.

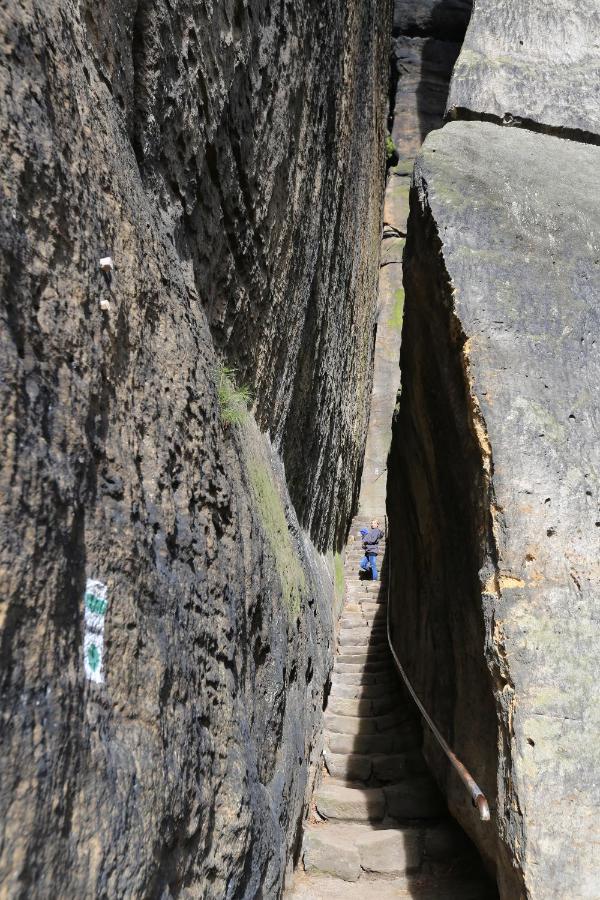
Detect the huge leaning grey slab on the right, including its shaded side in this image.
<box><xmin>389</xmin><ymin>123</ymin><xmax>600</xmax><ymax>900</ymax></box>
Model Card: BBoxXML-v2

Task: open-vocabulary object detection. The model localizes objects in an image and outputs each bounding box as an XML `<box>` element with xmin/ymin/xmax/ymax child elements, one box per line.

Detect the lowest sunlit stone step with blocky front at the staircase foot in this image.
<box><xmin>302</xmin><ymin>822</ymin><xmax>423</xmax><ymax>882</ymax></box>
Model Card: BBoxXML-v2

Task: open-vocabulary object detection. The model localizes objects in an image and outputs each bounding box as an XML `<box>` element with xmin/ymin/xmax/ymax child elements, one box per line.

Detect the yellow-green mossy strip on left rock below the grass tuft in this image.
<box><xmin>248</xmin><ymin>459</ymin><xmax>306</xmax><ymax>617</ymax></box>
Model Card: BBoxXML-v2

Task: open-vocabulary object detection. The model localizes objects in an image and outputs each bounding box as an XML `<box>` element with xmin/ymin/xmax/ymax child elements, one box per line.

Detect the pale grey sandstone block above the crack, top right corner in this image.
<box><xmin>448</xmin><ymin>0</ymin><xmax>600</xmax><ymax>144</ymax></box>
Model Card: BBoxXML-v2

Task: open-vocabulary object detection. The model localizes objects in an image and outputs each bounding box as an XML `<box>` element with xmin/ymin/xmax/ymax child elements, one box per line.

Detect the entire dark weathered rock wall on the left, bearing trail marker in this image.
<box><xmin>0</xmin><ymin>0</ymin><xmax>391</xmax><ymax>898</ymax></box>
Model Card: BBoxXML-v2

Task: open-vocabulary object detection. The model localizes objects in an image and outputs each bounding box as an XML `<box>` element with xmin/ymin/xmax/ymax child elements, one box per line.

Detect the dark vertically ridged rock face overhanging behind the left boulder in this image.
<box><xmin>82</xmin><ymin>0</ymin><xmax>389</xmax><ymax>547</ymax></box>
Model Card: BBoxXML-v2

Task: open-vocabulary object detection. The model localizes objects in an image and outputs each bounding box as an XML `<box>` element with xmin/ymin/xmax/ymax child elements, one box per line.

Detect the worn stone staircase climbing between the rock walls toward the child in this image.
<box><xmin>288</xmin><ymin>516</ymin><xmax>497</xmax><ymax>900</ymax></box>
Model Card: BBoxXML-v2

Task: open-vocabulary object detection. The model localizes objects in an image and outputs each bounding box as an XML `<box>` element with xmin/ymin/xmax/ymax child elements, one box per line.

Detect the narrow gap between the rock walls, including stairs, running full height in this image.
<box><xmin>291</xmin><ymin>4</ymin><xmax>497</xmax><ymax>900</ymax></box>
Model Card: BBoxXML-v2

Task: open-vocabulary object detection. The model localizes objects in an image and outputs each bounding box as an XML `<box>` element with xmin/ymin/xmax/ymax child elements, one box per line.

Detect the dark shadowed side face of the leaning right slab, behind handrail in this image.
<box><xmin>388</xmin><ymin>183</ymin><xmax>523</xmax><ymax>897</ymax></box>
